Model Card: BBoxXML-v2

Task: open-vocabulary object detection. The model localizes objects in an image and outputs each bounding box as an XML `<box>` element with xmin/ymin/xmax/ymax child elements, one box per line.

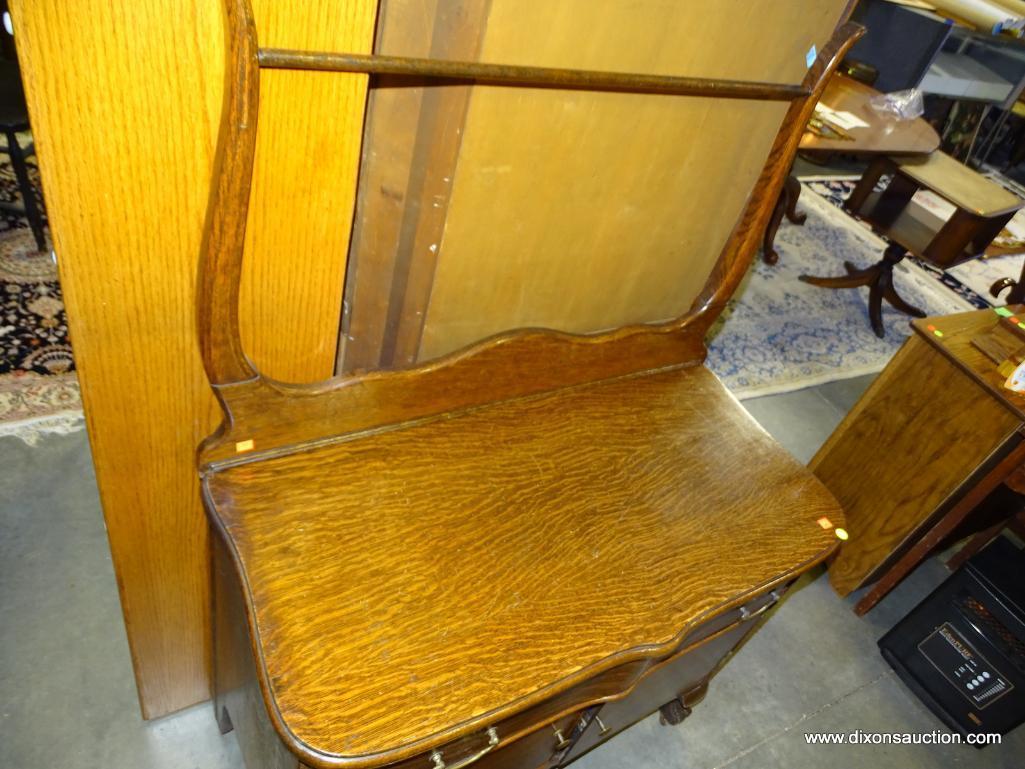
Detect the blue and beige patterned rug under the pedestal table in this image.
<box><xmin>708</xmin><ymin>177</ymin><xmax>1008</xmax><ymax>399</ymax></box>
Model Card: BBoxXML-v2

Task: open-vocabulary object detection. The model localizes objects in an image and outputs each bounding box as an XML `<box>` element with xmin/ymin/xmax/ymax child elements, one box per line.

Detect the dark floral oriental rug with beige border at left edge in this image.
<box><xmin>0</xmin><ymin>158</ymin><xmax>83</xmax><ymax>443</ymax></box>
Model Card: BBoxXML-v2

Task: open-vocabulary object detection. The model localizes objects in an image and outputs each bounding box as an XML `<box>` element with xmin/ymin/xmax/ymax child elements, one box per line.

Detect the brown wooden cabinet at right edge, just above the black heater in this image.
<box><xmin>809</xmin><ymin>306</ymin><xmax>1025</xmax><ymax>614</ymax></box>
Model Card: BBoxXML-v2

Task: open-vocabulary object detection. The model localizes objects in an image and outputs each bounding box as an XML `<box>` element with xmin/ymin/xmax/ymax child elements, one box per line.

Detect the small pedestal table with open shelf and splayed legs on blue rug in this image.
<box><xmin>801</xmin><ymin>152</ymin><xmax>1025</xmax><ymax>338</ymax></box>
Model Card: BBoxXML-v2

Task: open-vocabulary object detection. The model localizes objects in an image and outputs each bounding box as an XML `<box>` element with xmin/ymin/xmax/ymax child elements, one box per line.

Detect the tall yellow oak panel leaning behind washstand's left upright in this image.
<box><xmin>11</xmin><ymin>0</ymin><xmax>375</xmax><ymax>717</ymax></box>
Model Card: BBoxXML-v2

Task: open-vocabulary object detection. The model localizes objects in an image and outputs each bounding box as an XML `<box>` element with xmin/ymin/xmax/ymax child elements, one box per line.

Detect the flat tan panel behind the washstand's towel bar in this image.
<box><xmin>413</xmin><ymin>0</ymin><xmax>847</xmax><ymax>360</ymax></box>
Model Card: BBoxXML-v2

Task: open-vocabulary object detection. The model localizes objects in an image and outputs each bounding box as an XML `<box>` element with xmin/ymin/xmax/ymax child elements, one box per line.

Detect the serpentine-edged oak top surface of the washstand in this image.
<box><xmin>204</xmin><ymin>367</ymin><xmax>843</xmax><ymax>766</ymax></box>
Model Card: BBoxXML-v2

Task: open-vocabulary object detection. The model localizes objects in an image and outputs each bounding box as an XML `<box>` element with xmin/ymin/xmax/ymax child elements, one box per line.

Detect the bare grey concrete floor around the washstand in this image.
<box><xmin>0</xmin><ymin>377</ymin><xmax>1025</xmax><ymax>769</ymax></box>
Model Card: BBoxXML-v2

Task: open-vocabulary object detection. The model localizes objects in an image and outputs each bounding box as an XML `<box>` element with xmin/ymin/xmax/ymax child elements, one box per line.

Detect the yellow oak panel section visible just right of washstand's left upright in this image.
<box><xmin>242</xmin><ymin>0</ymin><xmax>377</xmax><ymax>381</ymax></box>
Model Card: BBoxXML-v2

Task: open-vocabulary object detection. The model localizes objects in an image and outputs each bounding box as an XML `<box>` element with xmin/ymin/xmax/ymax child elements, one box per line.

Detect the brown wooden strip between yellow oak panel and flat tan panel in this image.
<box><xmin>339</xmin><ymin>0</ymin><xmax>490</xmax><ymax>371</ymax></box>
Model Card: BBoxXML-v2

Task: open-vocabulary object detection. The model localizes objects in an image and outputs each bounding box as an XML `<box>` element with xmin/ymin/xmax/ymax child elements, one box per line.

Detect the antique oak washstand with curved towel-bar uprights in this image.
<box><xmin>198</xmin><ymin>0</ymin><xmax>860</xmax><ymax>769</ymax></box>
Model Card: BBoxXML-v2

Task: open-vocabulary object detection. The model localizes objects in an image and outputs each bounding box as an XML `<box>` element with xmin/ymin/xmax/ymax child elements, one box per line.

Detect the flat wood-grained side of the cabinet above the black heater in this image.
<box><xmin>809</xmin><ymin>332</ymin><xmax>1021</xmax><ymax>596</ymax></box>
